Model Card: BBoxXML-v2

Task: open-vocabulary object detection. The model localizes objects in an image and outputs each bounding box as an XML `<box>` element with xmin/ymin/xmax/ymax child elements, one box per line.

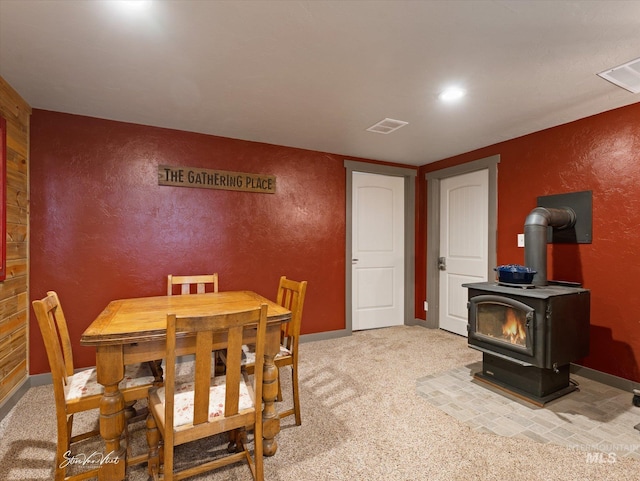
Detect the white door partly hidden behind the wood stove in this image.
<box><xmin>439</xmin><ymin>170</ymin><xmax>489</xmax><ymax>337</ymax></box>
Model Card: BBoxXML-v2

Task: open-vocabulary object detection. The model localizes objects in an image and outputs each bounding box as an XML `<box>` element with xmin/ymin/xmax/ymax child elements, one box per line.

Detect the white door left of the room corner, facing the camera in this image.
<box><xmin>351</xmin><ymin>172</ymin><xmax>404</xmax><ymax>331</ymax></box>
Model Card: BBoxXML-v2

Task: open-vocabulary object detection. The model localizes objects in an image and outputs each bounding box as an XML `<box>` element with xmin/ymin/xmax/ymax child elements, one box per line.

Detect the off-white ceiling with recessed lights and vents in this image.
<box><xmin>0</xmin><ymin>0</ymin><xmax>640</xmax><ymax>165</ymax></box>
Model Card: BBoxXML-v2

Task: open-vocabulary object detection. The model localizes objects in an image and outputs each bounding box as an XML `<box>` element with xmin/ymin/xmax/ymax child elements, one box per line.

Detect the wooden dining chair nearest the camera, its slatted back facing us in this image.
<box><xmin>147</xmin><ymin>304</ymin><xmax>267</xmax><ymax>481</ymax></box>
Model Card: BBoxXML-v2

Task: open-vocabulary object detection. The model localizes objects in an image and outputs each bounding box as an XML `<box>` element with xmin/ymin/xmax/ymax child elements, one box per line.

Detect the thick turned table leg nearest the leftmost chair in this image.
<box><xmin>96</xmin><ymin>346</ymin><xmax>127</xmax><ymax>481</ymax></box>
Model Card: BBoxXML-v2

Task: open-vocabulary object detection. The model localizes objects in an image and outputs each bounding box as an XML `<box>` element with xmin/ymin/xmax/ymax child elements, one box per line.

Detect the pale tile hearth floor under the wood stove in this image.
<box><xmin>416</xmin><ymin>362</ymin><xmax>640</xmax><ymax>459</ymax></box>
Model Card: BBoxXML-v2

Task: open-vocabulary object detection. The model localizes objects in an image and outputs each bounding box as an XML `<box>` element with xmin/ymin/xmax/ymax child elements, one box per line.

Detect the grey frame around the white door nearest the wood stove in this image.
<box><xmin>425</xmin><ymin>154</ymin><xmax>500</xmax><ymax>329</ymax></box>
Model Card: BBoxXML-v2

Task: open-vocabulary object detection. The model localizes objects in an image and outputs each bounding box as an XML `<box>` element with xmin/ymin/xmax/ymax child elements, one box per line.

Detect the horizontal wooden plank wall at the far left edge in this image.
<box><xmin>0</xmin><ymin>77</ymin><xmax>31</xmax><ymax>405</ymax></box>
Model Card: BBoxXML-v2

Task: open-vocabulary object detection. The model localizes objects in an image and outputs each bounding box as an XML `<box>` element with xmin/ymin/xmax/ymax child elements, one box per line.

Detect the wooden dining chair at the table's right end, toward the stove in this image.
<box><xmin>243</xmin><ymin>276</ymin><xmax>307</xmax><ymax>426</ymax></box>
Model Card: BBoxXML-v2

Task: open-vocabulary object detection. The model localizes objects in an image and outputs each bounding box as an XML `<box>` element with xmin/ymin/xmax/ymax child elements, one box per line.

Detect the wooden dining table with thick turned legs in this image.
<box><xmin>80</xmin><ymin>291</ymin><xmax>291</xmax><ymax>481</ymax></box>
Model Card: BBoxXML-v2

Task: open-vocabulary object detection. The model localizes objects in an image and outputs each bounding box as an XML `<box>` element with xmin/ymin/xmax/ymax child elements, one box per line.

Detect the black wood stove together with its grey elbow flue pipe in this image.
<box><xmin>463</xmin><ymin>192</ymin><xmax>591</xmax><ymax>405</ymax></box>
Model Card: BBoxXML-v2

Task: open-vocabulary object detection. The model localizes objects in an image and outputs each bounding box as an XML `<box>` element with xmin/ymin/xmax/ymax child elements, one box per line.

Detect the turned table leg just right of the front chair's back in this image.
<box><xmin>262</xmin><ymin>324</ymin><xmax>280</xmax><ymax>456</ymax></box>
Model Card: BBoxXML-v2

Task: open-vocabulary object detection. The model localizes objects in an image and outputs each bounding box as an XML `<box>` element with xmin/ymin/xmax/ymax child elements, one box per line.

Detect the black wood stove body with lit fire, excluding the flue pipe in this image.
<box><xmin>463</xmin><ymin>282</ymin><xmax>590</xmax><ymax>405</ymax></box>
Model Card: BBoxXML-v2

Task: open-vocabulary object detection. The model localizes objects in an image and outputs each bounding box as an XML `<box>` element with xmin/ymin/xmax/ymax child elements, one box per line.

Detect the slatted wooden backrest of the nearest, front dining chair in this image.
<box><xmin>165</xmin><ymin>304</ymin><xmax>267</xmax><ymax>444</ymax></box>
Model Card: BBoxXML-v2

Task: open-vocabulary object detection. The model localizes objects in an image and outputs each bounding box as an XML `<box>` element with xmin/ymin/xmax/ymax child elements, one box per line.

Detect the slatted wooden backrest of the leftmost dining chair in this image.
<box><xmin>31</xmin><ymin>291</ymin><xmax>73</xmax><ymax>406</ymax></box>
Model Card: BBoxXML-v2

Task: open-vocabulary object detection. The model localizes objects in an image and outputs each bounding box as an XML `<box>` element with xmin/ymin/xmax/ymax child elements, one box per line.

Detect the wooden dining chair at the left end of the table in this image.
<box><xmin>32</xmin><ymin>291</ymin><xmax>154</xmax><ymax>481</ymax></box>
